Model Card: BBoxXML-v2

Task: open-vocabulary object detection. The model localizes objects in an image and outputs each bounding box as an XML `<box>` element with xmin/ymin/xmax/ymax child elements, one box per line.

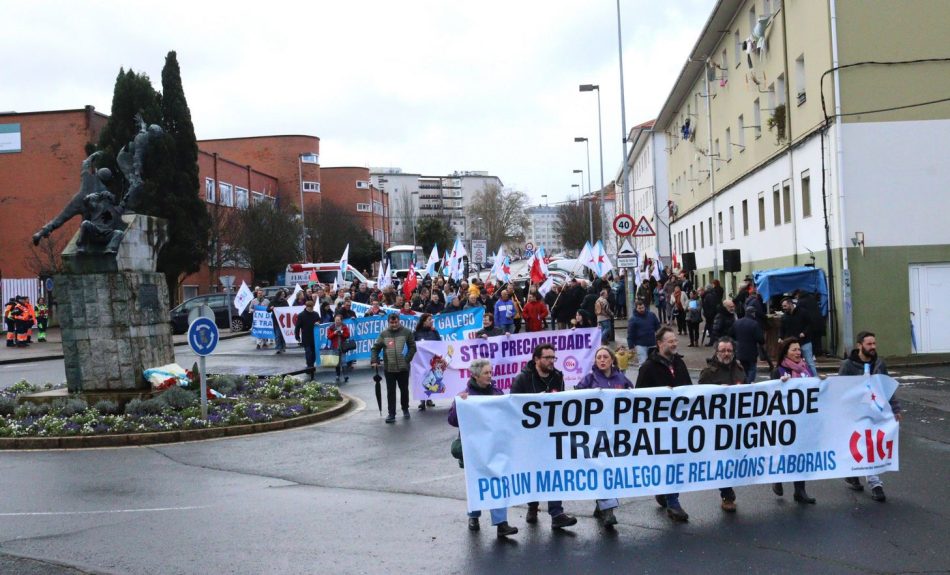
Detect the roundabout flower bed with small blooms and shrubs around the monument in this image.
<box><xmin>0</xmin><ymin>376</ymin><xmax>344</xmax><ymax>439</ymax></box>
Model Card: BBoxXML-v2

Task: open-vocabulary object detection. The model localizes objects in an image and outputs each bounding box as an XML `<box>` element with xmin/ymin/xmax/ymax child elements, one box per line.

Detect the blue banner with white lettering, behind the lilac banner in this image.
<box><xmin>316</xmin><ymin>306</ymin><xmax>485</xmax><ymax>365</ymax></box>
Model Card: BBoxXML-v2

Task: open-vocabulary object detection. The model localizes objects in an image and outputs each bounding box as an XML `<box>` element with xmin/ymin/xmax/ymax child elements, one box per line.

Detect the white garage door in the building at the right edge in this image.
<box><xmin>910</xmin><ymin>263</ymin><xmax>950</xmax><ymax>353</ymax></box>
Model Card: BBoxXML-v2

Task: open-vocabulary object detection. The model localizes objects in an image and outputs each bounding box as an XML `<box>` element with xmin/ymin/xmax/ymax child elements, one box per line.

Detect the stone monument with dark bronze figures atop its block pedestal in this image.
<box><xmin>33</xmin><ymin>119</ymin><xmax>175</xmax><ymax>400</ymax></box>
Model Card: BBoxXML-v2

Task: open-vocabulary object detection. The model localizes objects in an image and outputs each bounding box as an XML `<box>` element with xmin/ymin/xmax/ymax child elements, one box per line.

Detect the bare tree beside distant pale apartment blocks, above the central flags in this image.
<box><xmin>468</xmin><ymin>184</ymin><xmax>529</xmax><ymax>249</ymax></box>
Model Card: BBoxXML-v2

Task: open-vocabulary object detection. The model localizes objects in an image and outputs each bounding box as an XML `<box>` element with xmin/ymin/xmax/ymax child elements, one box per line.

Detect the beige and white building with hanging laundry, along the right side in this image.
<box><xmin>654</xmin><ymin>0</ymin><xmax>950</xmax><ymax>356</ymax></box>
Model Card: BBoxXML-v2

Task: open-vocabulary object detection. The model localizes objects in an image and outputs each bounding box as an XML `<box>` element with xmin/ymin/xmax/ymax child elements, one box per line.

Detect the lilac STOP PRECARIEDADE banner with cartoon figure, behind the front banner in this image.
<box><xmin>410</xmin><ymin>326</ymin><xmax>600</xmax><ymax>400</ymax></box>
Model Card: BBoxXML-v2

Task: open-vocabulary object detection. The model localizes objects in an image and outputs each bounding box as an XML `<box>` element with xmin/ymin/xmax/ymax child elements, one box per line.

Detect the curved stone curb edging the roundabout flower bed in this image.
<box><xmin>0</xmin><ymin>394</ymin><xmax>355</xmax><ymax>451</ymax></box>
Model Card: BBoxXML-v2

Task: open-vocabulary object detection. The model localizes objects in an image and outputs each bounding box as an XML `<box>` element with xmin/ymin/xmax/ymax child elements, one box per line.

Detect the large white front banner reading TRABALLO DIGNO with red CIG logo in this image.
<box><xmin>455</xmin><ymin>375</ymin><xmax>899</xmax><ymax>511</ymax></box>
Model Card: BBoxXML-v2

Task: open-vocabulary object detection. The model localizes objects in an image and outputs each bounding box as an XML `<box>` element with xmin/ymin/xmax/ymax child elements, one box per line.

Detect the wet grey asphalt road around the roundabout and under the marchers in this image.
<box><xmin>0</xmin><ymin>344</ymin><xmax>950</xmax><ymax>574</ymax></box>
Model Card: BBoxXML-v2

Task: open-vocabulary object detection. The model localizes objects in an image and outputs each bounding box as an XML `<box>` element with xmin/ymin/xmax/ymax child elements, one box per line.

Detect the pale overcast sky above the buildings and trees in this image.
<box><xmin>0</xmin><ymin>0</ymin><xmax>715</xmax><ymax>206</ymax></box>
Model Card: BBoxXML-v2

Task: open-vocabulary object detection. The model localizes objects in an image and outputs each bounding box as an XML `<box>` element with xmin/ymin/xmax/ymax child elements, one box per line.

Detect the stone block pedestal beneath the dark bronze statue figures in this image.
<box><xmin>55</xmin><ymin>214</ymin><xmax>175</xmax><ymax>392</ymax></box>
